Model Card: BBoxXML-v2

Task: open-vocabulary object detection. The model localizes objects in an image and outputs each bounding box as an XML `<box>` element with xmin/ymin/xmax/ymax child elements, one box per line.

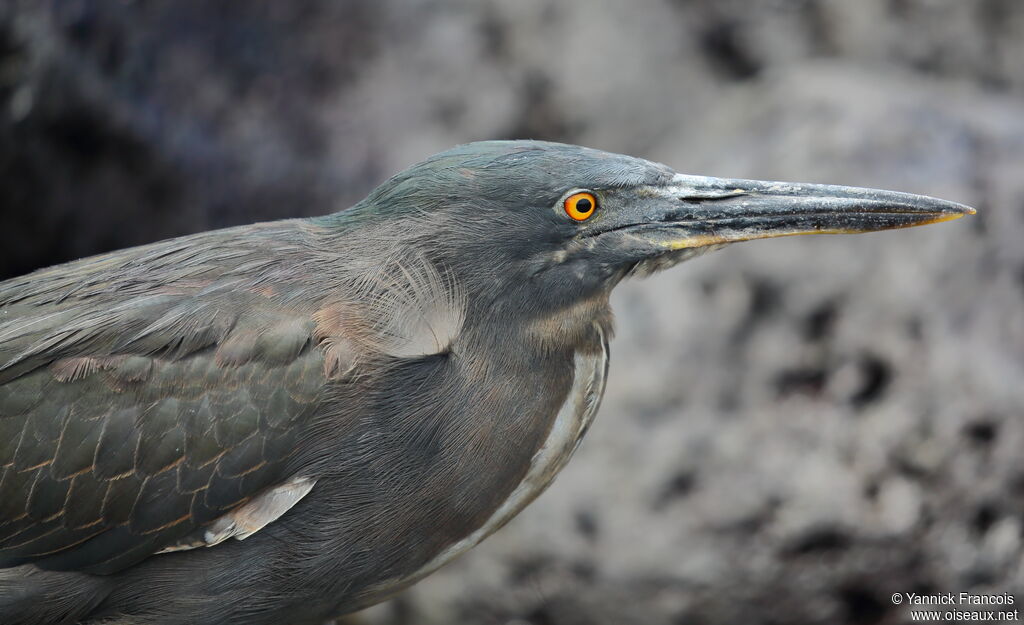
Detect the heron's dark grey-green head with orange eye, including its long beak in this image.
<box><xmin>339</xmin><ymin>141</ymin><xmax>974</xmax><ymax>325</ymax></box>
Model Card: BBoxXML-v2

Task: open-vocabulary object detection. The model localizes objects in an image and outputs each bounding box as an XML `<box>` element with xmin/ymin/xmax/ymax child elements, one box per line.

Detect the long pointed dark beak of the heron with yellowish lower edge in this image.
<box><xmin>634</xmin><ymin>174</ymin><xmax>975</xmax><ymax>249</ymax></box>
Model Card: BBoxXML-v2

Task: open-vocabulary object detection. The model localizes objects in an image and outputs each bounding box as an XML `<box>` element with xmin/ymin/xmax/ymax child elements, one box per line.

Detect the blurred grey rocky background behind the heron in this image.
<box><xmin>0</xmin><ymin>0</ymin><xmax>1024</xmax><ymax>625</ymax></box>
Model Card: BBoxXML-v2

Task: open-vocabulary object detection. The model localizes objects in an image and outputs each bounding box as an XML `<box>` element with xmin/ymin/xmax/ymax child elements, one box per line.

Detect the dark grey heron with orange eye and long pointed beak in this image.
<box><xmin>0</xmin><ymin>140</ymin><xmax>974</xmax><ymax>625</ymax></box>
